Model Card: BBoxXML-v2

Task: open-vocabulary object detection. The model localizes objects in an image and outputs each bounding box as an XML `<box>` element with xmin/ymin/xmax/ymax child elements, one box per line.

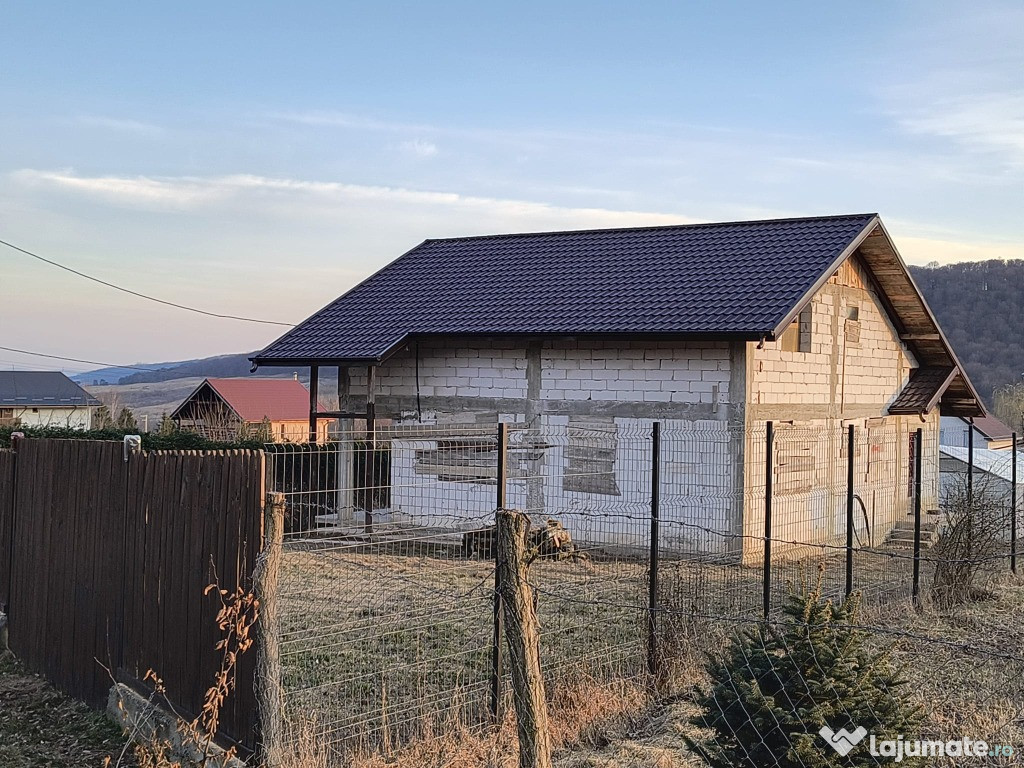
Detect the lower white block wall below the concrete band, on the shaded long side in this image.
<box><xmin>391</xmin><ymin>416</ymin><xmax>742</xmax><ymax>555</ymax></box>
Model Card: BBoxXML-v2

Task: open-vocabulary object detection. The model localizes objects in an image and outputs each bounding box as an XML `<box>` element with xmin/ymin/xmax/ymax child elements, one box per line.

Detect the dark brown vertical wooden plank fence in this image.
<box><xmin>0</xmin><ymin>439</ymin><xmax>264</xmax><ymax>750</ymax></box>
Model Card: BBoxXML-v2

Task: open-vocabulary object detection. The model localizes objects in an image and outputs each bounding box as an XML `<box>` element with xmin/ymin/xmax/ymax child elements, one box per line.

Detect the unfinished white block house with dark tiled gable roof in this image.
<box><xmin>252</xmin><ymin>214</ymin><xmax>985</xmax><ymax>559</ymax></box>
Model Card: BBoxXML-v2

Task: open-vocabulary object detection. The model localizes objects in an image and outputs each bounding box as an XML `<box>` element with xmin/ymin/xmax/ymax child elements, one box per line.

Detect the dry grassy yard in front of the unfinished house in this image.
<box><xmin>272</xmin><ymin>538</ymin><xmax>1024</xmax><ymax>765</ymax></box>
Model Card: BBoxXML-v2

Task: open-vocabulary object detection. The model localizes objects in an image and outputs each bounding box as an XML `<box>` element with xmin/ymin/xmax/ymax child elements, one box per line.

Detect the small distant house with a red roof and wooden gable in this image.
<box><xmin>170</xmin><ymin>379</ymin><xmax>331</xmax><ymax>442</ymax></box>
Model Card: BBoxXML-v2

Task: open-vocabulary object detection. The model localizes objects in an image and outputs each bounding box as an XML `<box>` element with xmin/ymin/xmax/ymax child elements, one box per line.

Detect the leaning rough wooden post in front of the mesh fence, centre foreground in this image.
<box><xmin>497</xmin><ymin>509</ymin><xmax>551</xmax><ymax>768</ymax></box>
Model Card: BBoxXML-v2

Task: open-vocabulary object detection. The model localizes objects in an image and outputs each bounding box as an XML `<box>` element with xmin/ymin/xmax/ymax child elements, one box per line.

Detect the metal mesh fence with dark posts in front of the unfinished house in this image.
<box><xmin>268</xmin><ymin>417</ymin><xmax>1024</xmax><ymax>765</ymax></box>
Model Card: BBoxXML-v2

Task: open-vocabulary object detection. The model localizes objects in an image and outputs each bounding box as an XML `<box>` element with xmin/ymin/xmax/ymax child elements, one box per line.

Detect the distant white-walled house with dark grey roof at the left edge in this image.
<box><xmin>0</xmin><ymin>371</ymin><xmax>103</xmax><ymax>429</ymax></box>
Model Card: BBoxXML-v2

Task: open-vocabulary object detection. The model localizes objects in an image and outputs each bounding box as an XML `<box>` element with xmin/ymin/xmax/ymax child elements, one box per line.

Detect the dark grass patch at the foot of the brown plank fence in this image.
<box><xmin>0</xmin><ymin>654</ymin><xmax>134</xmax><ymax>768</ymax></box>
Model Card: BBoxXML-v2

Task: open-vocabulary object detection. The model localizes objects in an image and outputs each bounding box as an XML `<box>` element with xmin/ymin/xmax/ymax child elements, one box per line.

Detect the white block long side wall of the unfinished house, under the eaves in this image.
<box><xmin>372</xmin><ymin>340</ymin><xmax>742</xmax><ymax>553</ymax></box>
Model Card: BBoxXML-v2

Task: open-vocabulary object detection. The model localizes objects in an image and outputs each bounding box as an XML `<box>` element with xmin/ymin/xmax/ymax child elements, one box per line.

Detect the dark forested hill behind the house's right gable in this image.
<box><xmin>910</xmin><ymin>259</ymin><xmax>1024</xmax><ymax>406</ymax></box>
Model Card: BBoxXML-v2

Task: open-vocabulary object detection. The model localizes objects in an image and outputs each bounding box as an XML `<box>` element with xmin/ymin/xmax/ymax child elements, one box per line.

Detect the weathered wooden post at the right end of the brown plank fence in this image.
<box><xmin>253</xmin><ymin>494</ymin><xmax>285</xmax><ymax>768</ymax></box>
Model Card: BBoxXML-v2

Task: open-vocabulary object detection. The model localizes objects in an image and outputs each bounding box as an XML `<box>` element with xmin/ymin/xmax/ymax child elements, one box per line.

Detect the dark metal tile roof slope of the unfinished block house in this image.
<box><xmin>253</xmin><ymin>213</ymin><xmax>876</xmax><ymax>365</ymax></box>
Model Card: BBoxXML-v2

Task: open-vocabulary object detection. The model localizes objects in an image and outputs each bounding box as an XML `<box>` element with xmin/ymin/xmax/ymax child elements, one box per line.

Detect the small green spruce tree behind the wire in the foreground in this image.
<box><xmin>685</xmin><ymin>569</ymin><xmax>923</xmax><ymax>768</ymax></box>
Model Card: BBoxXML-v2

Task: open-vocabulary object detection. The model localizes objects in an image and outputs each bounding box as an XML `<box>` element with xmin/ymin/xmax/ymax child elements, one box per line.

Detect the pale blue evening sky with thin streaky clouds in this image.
<box><xmin>0</xmin><ymin>0</ymin><xmax>1024</xmax><ymax>372</ymax></box>
